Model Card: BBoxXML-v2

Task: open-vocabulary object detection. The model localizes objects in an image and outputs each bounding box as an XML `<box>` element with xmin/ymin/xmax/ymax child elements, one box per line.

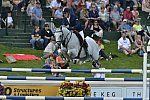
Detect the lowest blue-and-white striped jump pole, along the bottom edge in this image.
<box><xmin>0</xmin><ymin>96</ymin><xmax>144</xmax><ymax>100</ymax></box>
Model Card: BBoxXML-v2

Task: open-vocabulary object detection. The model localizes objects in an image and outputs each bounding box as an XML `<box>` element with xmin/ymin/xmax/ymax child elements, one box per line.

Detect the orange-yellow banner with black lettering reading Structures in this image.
<box><xmin>4</xmin><ymin>86</ymin><xmax>59</xmax><ymax>96</ymax></box>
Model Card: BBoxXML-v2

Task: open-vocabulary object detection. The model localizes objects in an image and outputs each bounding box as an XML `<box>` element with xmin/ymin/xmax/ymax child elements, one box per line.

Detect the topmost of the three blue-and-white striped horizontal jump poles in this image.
<box><xmin>0</xmin><ymin>68</ymin><xmax>150</xmax><ymax>73</ymax></box>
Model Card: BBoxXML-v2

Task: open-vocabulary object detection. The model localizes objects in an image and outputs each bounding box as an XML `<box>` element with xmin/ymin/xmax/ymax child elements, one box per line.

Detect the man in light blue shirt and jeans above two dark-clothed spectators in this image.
<box><xmin>31</xmin><ymin>2</ymin><xmax>45</xmax><ymax>28</ymax></box>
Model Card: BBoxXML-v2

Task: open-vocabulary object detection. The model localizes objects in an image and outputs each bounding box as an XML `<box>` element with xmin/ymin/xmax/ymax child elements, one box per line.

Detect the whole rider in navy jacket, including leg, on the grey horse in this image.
<box><xmin>63</xmin><ymin>8</ymin><xmax>88</xmax><ymax>56</ymax></box>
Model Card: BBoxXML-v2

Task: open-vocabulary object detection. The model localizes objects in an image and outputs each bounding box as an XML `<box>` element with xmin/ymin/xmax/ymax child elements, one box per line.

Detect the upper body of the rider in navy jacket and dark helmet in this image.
<box><xmin>63</xmin><ymin>8</ymin><xmax>82</xmax><ymax>32</ymax></box>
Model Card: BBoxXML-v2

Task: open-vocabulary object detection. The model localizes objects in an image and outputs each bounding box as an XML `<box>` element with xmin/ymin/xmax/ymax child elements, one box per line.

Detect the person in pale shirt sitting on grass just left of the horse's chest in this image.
<box><xmin>42</xmin><ymin>37</ymin><xmax>57</xmax><ymax>59</ymax></box>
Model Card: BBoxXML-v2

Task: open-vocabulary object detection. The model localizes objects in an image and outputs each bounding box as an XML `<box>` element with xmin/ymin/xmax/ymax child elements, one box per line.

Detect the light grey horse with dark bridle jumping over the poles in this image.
<box><xmin>54</xmin><ymin>26</ymin><xmax>100</xmax><ymax>68</ymax></box>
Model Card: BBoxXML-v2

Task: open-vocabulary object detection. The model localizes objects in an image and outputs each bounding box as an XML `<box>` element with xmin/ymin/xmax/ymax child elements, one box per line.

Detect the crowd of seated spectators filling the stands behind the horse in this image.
<box><xmin>1</xmin><ymin>0</ymin><xmax>150</xmax><ymax>54</ymax></box>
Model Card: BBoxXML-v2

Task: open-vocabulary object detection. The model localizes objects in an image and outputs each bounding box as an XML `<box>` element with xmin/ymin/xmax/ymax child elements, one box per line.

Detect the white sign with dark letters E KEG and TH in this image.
<box><xmin>91</xmin><ymin>87</ymin><xmax>149</xmax><ymax>98</ymax></box>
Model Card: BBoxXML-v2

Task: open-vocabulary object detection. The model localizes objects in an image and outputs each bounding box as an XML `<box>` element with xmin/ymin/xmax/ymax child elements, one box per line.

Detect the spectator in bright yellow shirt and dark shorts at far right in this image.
<box><xmin>133</xmin><ymin>20</ymin><xmax>150</xmax><ymax>43</ymax></box>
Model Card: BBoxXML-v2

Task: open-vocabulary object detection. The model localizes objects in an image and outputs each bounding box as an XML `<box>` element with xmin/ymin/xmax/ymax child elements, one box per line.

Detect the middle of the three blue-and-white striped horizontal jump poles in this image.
<box><xmin>0</xmin><ymin>76</ymin><xmax>150</xmax><ymax>81</ymax></box>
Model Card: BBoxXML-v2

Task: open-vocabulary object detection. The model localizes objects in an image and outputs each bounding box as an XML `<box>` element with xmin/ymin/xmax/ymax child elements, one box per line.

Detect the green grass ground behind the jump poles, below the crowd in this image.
<box><xmin>0</xmin><ymin>41</ymin><xmax>148</xmax><ymax>77</ymax></box>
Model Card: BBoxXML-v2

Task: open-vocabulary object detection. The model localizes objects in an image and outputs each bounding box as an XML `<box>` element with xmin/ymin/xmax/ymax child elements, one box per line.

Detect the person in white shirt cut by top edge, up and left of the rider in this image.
<box><xmin>50</xmin><ymin>0</ymin><xmax>61</xmax><ymax>16</ymax></box>
